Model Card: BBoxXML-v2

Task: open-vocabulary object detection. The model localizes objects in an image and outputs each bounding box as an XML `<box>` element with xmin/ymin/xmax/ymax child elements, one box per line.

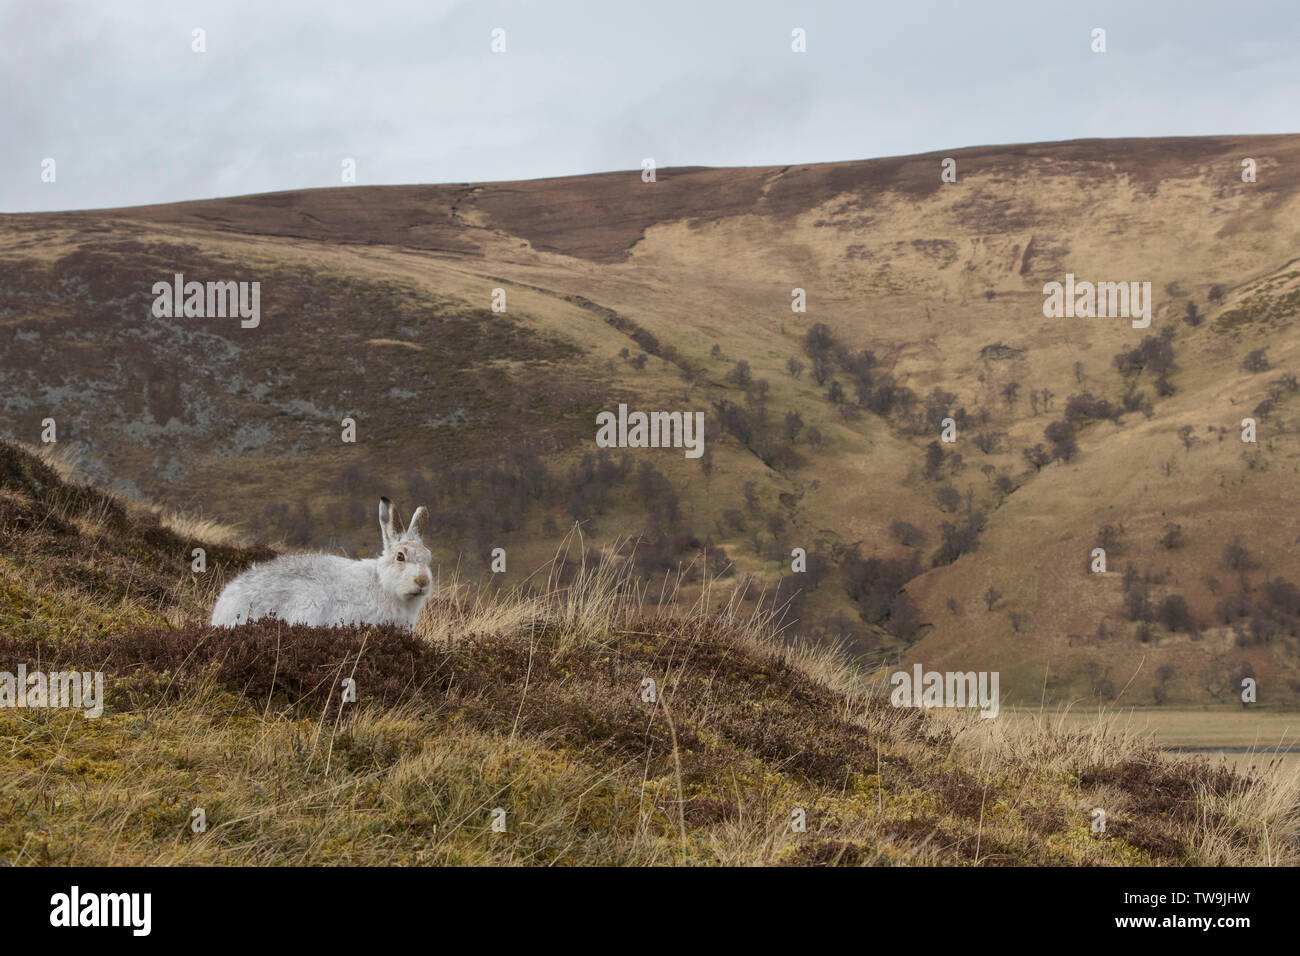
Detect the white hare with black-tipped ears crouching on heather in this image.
<box><xmin>212</xmin><ymin>498</ymin><xmax>433</xmax><ymax>628</ymax></box>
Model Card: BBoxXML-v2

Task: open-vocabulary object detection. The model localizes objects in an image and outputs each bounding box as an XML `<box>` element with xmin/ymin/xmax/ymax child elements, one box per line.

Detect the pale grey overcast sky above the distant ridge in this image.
<box><xmin>0</xmin><ymin>0</ymin><xmax>1300</xmax><ymax>212</ymax></box>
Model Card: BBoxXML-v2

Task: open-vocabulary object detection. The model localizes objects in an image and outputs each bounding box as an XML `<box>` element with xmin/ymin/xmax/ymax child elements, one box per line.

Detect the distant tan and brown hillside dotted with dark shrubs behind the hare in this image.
<box><xmin>0</xmin><ymin>135</ymin><xmax>1300</xmax><ymax>708</ymax></box>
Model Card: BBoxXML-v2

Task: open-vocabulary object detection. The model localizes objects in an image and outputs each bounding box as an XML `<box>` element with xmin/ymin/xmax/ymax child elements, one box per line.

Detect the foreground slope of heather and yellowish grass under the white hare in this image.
<box><xmin>0</xmin><ymin>444</ymin><xmax>1300</xmax><ymax>865</ymax></box>
